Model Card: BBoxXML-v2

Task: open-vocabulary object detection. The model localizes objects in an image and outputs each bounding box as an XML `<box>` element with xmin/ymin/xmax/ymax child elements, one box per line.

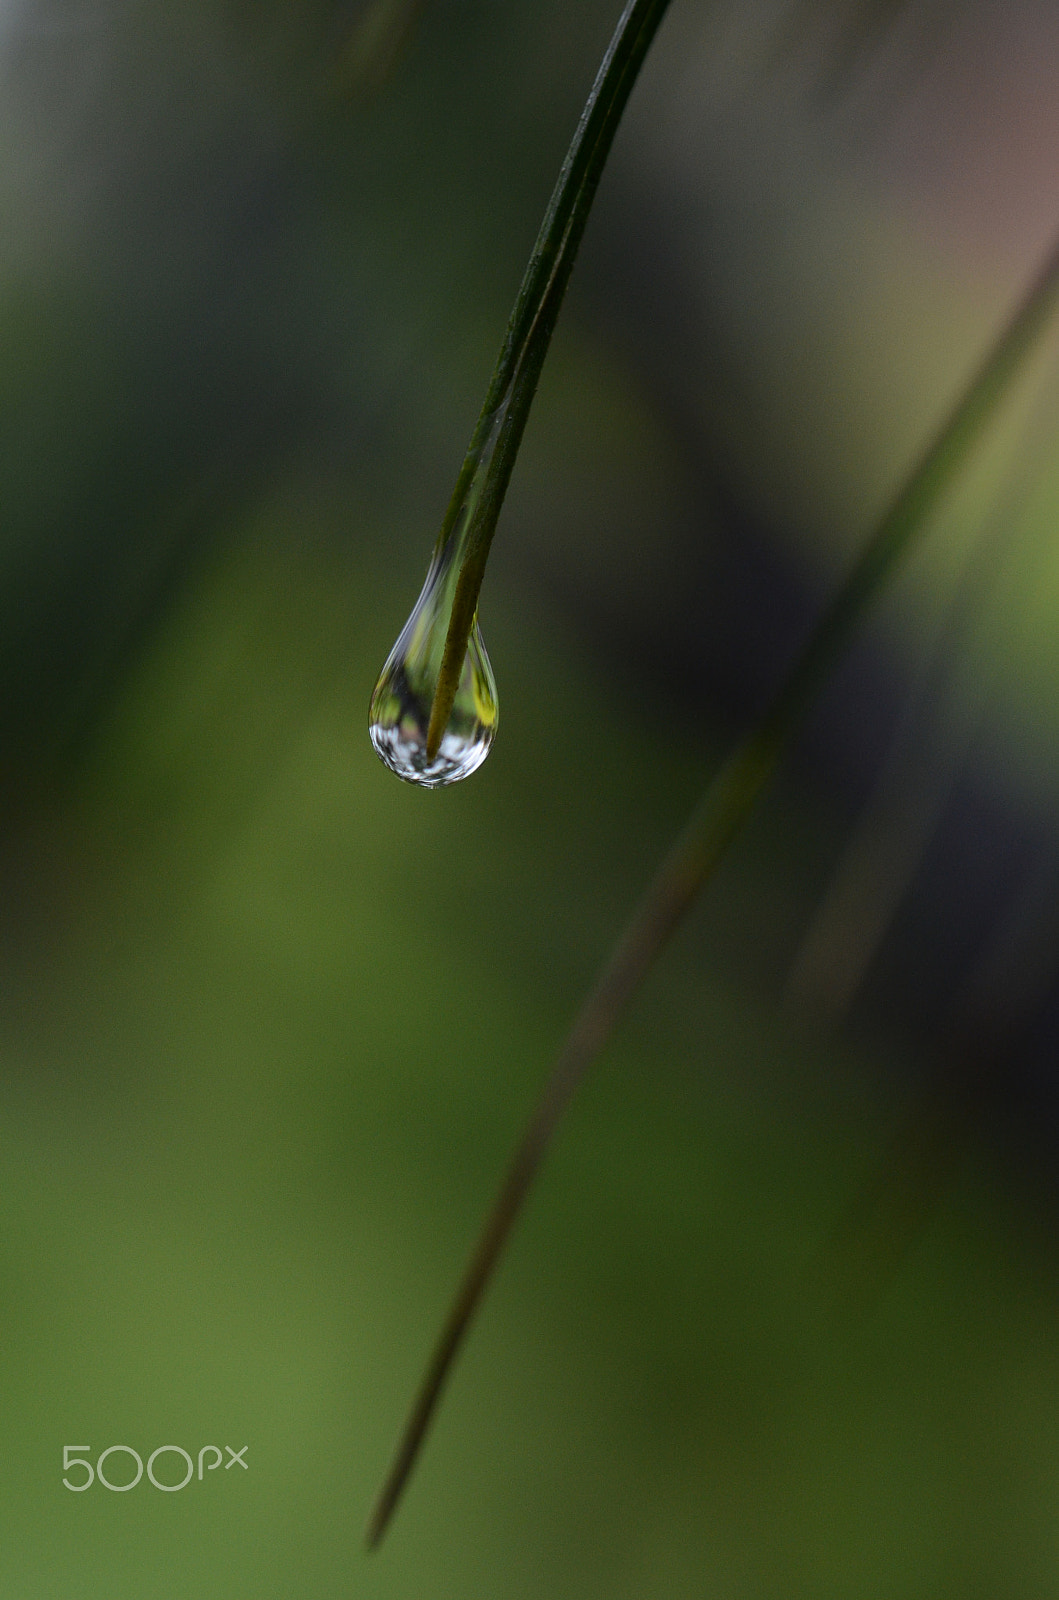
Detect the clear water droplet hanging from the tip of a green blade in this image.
<box><xmin>368</xmin><ymin>541</ymin><xmax>498</xmax><ymax>789</ymax></box>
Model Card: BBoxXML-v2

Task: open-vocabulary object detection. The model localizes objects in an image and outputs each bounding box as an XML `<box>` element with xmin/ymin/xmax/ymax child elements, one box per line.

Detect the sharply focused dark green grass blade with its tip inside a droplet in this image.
<box><xmin>427</xmin><ymin>0</ymin><xmax>669</xmax><ymax>758</ymax></box>
